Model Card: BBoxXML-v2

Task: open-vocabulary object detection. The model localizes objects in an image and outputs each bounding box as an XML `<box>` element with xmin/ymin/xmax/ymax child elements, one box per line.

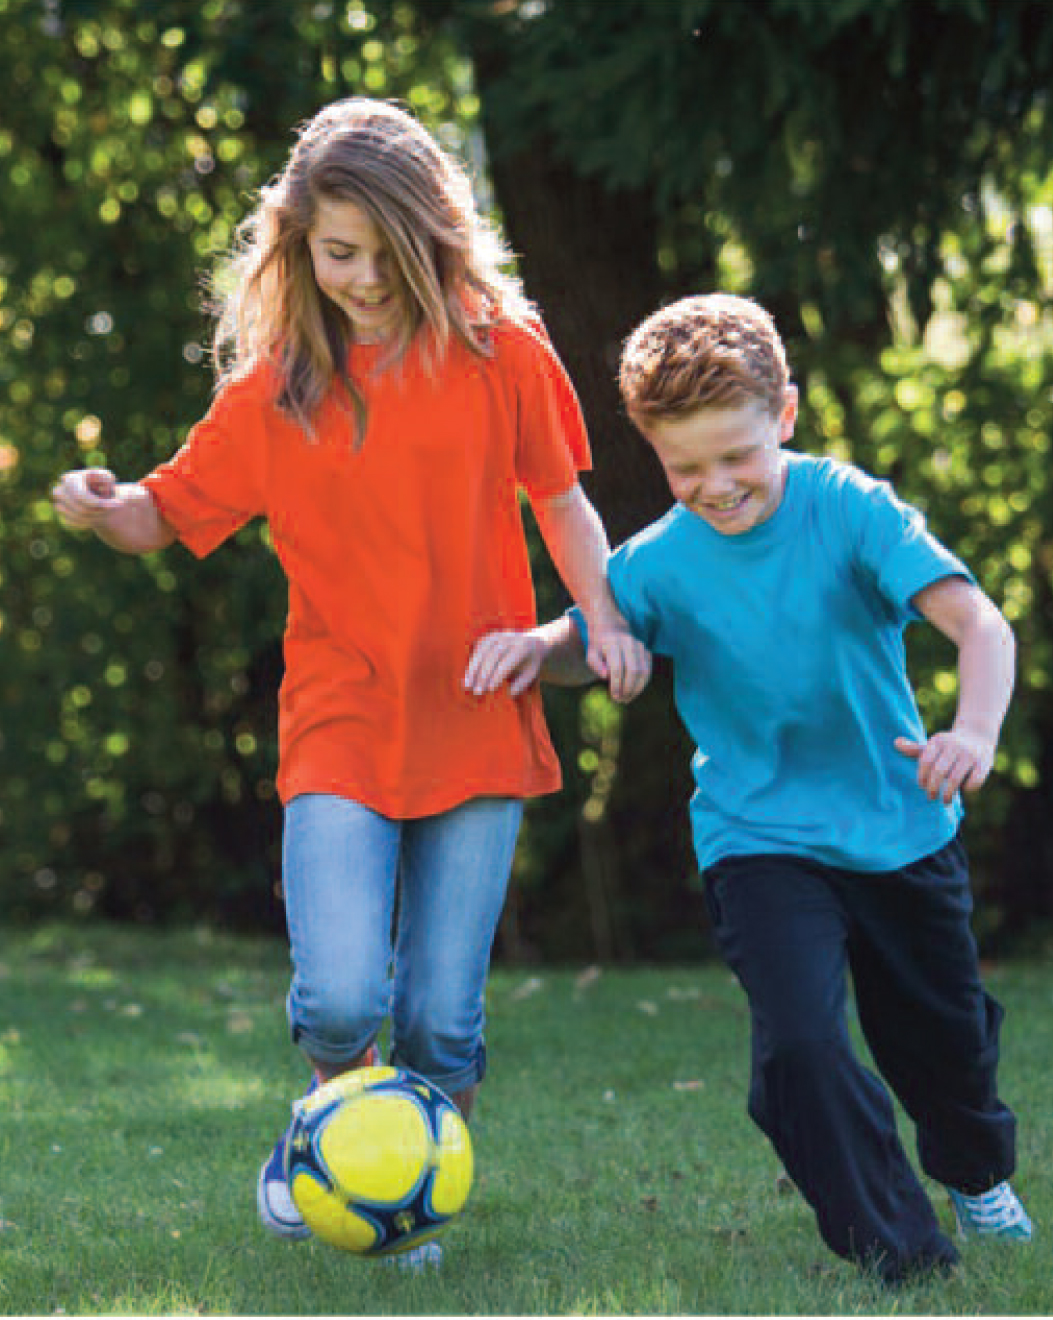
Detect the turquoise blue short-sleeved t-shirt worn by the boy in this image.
<box><xmin>574</xmin><ymin>453</ymin><xmax>973</xmax><ymax>871</ymax></box>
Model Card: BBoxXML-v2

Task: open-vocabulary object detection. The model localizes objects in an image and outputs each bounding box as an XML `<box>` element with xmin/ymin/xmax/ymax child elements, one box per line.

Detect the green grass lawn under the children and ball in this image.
<box><xmin>0</xmin><ymin>928</ymin><xmax>1053</xmax><ymax>1315</ymax></box>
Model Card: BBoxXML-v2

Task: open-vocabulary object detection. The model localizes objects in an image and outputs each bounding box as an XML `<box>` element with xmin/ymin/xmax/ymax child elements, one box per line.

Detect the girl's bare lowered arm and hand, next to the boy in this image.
<box><xmin>533</xmin><ymin>482</ymin><xmax>651</xmax><ymax>701</ymax></box>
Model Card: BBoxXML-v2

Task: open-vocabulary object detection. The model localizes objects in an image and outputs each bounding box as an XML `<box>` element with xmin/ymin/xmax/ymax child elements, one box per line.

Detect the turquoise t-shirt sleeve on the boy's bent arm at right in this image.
<box><xmin>841</xmin><ymin>470</ymin><xmax>975</xmax><ymax>619</ymax></box>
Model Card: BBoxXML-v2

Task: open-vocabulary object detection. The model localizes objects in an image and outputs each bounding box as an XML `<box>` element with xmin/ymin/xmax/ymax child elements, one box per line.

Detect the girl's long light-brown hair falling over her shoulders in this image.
<box><xmin>212</xmin><ymin>98</ymin><xmax>532</xmax><ymax>442</ymax></box>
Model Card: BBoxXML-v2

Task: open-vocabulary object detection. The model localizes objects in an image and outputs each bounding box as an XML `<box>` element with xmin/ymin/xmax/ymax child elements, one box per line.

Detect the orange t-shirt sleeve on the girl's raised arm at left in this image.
<box><xmin>143</xmin><ymin>376</ymin><xmax>267</xmax><ymax>558</ymax></box>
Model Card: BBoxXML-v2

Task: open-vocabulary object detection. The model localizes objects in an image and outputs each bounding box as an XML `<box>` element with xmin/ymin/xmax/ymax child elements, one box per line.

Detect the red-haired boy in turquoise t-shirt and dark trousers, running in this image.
<box><xmin>466</xmin><ymin>294</ymin><xmax>1032</xmax><ymax>1282</ymax></box>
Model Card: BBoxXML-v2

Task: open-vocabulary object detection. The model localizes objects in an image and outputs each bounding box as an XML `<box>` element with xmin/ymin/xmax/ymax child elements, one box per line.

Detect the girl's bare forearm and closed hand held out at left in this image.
<box><xmin>51</xmin><ymin>467</ymin><xmax>176</xmax><ymax>554</ymax></box>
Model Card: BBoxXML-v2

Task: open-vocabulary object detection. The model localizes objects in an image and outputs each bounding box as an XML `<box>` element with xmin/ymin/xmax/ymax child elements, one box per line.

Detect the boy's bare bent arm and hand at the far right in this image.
<box><xmin>896</xmin><ymin>577</ymin><xmax>1016</xmax><ymax>803</ymax></box>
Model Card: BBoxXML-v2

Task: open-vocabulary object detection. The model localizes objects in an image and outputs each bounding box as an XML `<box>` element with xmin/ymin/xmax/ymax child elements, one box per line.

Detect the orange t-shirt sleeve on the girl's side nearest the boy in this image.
<box><xmin>499</xmin><ymin>323</ymin><xmax>592</xmax><ymax>502</ymax></box>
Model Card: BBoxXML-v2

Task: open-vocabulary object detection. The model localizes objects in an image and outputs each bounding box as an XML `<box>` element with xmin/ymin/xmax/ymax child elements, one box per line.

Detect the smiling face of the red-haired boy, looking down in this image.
<box><xmin>645</xmin><ymin>385</ymin><xmax>797</xmax><ymax>536</ymax></box>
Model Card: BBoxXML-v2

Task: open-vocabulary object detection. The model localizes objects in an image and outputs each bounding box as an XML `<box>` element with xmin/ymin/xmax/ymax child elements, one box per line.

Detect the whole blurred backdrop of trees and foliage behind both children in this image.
<box><xmin>0</xmin><ymin>0</ymin><xmax>1053</xmax><ymax>961</ymax></box>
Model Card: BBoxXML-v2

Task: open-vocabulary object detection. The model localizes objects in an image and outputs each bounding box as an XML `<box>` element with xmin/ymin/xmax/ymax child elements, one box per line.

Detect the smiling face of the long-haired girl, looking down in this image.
<box><xmin>307</xmin><ymin>197</ymin><xmax>405</xmax><ymax>343</ymax></box>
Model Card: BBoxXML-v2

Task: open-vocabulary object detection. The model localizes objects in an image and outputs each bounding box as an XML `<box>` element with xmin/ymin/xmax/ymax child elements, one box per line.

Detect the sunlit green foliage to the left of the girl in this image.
<box><xmin>0</xmin><ymin>0</ymin><xmax>474</xmax><ymax>921</ymax></box>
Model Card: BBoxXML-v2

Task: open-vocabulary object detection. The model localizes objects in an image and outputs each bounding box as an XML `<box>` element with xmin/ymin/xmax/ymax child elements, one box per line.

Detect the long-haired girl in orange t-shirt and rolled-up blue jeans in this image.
<box><xmin>53</xmin><ymin>99</ymin><xmax>648</xmax><ymax>1259</ymax></box>
